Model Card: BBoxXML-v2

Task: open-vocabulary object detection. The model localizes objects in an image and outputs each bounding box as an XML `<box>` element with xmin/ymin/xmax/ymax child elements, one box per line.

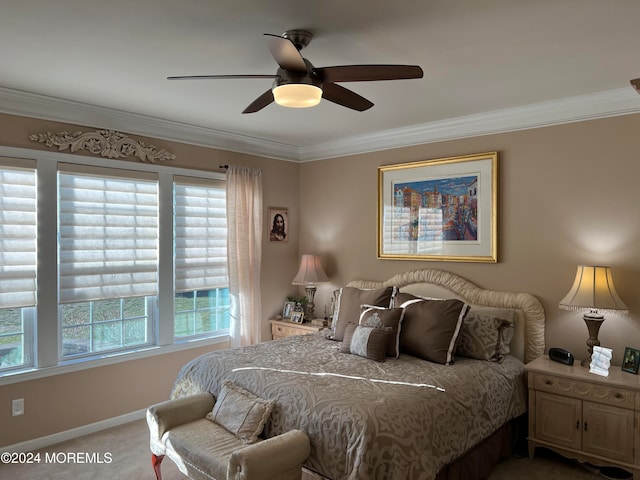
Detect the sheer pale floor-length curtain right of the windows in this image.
<box><xmin>227</xmin><ymin>166</ymin><xmax>262</xmax><ymax>347</ymax></box>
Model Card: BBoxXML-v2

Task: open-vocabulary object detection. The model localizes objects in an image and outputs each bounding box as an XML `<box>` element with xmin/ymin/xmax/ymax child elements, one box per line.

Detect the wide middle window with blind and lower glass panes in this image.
<box><xmin>58</xmin><ymin>165</ymin><xmax>159</xmax><ymax>358</ymax></box>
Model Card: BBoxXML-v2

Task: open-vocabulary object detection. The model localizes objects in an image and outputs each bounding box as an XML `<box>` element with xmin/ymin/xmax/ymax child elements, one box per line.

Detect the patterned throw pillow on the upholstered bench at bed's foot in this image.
<box><xmin>207</xmin><ymin>380</ymin><xmax>274</xmax><ymax>443</ymax></box>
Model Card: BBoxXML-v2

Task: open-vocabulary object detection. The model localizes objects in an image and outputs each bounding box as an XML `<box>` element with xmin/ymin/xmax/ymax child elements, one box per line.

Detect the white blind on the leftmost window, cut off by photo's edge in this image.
<box><xmin>0</xmin><ymin>159</ymin><xmax>37</xmax><ymax>308</ymax></box>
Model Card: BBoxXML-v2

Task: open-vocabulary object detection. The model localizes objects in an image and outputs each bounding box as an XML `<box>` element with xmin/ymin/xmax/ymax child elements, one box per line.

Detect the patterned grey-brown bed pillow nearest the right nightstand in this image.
<box><xmin>455</xmin><ymin>307</ymin><xmax>515</xmax><ymax>362</ymax></box>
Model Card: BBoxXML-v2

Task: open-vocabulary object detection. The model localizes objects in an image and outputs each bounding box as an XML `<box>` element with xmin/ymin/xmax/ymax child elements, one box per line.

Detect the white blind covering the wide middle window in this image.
<box><xmin>58</xmin><ymin>165</ymin><xmax>158</xmax><ymax>303</ymax></box>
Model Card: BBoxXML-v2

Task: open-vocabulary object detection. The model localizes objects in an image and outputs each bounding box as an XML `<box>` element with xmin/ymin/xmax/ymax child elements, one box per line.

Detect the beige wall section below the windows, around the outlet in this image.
<box><xmin>0</xmin><ymin>343</ymin><xmax>228</xmax><ymax>446</ymax></box>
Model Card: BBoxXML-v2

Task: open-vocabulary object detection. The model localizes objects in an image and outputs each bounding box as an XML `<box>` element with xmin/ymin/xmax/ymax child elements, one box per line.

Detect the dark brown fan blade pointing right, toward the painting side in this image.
<box><xmin>313</xmin><ymin>65</ymin><xmax>424</xmax><ymax>82</ymax></box>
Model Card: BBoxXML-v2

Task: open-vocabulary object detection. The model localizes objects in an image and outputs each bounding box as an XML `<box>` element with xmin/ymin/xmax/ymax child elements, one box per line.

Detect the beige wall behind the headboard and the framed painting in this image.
<box><xmin>300</xmin><ymin>115</ymin><xmax>640</xmax><ymax>365</ymax></box>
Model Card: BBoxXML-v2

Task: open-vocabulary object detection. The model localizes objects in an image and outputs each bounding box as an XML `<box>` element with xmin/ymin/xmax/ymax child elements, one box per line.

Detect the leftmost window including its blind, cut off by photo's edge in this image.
<box><xmin>0</xmin><ymin>158</ymin><xmax>37</xmax><ymax>370</ymax></box>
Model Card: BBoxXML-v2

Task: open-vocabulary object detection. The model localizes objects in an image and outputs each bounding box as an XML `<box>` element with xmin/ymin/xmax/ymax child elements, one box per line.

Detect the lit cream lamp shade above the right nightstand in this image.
<box><xmin>559</xmin><ymin>265</ymin><xmax>628</xmax><ymax>313</ymax></box>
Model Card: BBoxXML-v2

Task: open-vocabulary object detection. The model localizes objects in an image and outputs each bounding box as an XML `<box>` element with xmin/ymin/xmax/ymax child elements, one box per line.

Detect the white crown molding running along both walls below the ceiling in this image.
<box><xmin>0</xmin><ymin>87</ymin><xmax>640</xmax><ymax>162</ymax></box>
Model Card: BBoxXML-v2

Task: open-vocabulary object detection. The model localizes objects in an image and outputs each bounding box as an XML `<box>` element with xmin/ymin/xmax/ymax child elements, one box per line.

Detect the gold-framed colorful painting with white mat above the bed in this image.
<box><xmin>378</xmin><ymin>152</ymin><xmax>498</xmax><ymax>263</ymax></box>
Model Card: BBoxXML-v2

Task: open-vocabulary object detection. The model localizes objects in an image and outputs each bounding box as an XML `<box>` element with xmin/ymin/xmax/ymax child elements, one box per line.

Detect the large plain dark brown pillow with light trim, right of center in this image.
<box><xmin>400</xmin><ymin>299</ymin><xmax>469</xmax><ymax>365</ymax></box>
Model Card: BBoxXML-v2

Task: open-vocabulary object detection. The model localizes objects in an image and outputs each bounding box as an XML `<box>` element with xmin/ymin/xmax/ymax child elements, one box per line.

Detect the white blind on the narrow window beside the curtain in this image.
<box><xmin>174</xmin><ymin>177</ymin><xmax>229</xmax><ymax>292</ymax></box>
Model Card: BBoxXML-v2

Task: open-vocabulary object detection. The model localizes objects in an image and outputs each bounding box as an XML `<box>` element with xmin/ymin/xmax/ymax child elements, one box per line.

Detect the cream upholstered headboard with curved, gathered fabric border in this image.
<box><xmin>347</xmin><ymin>269</ymin><xmax>545</xmax><ymax>363</ymax></box>
